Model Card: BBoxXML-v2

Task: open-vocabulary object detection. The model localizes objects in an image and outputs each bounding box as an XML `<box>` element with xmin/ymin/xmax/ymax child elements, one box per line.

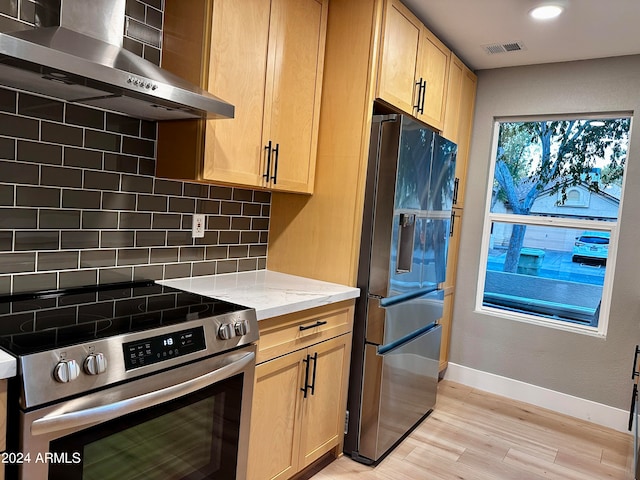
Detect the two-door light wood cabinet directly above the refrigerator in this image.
<box><xmin>377</xmin><ymin>0</ymin><xmax>450</xmax><ymax>130</ymax></box>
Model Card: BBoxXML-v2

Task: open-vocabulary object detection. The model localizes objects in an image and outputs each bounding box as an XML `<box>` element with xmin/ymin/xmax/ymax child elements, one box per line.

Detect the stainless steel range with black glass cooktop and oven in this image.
<box><xmin>0</xmin><ymin>282</ymin><xmax>258</xmax><ymax>480</ymax></box>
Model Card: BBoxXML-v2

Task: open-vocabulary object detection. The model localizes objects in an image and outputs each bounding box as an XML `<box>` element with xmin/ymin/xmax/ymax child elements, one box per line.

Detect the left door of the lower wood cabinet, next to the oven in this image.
<box><xmin>247</xmin><ymin>350</ymin><xmax>307</xmax><ymax>480</ymax></box>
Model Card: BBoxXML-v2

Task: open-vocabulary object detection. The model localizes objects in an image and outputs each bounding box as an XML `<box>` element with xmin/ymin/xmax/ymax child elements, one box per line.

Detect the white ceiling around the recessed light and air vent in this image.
<box><xmin>403</xmin><ymin>0</ymin><xmax>640</xmax><ymax>70</ymax></box>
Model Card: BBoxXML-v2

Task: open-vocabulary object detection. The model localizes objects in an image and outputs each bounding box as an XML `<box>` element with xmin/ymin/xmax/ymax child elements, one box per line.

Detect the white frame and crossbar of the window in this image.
<box><xmin>475</xmin><ymin>116</ymin><xmax>633</xmax><ymax>338</ymax></box>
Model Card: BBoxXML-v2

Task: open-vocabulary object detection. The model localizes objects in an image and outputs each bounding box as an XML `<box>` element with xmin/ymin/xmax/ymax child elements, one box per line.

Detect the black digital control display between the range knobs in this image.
<box><xmin>122</xmin><ymin>327</ymin><xmax>206</xmax><ymax>370</ymax></box>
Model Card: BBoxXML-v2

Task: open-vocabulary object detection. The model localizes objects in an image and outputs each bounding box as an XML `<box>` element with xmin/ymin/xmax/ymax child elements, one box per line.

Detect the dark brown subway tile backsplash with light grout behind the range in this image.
<box><xmin>0</xmin><ymin>0</ymin><xmax>271</xmax><ymax>294</ymax></box>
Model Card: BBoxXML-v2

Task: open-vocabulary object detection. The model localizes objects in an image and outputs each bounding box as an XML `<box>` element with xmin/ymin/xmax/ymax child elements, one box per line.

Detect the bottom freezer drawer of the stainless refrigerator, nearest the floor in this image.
<box><xmin>353</xmin><ymin>325</ymin><xmax>442</xmax><ymax>463</ymax></box>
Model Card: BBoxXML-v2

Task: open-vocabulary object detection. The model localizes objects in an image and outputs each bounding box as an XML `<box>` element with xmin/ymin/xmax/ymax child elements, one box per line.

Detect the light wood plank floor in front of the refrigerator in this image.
<box><xmin>312</xmin><ymin>380</ymin><xmax>633</xmax><ymax>480</ymax></box>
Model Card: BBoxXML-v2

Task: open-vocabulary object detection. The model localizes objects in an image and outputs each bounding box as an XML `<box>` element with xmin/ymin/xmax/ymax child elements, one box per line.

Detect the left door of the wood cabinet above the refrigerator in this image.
<box><xmin>377</xmin><ymin>0</ymin><xmax>423</xmax><ymax>115</ymax></box>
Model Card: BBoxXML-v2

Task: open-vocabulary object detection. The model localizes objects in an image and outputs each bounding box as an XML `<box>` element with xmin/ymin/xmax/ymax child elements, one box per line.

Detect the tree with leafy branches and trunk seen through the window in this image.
<box><xmin>494</xmin><ymin>118</ymin><xmax>630</xmax><ymax>272</ymax></box>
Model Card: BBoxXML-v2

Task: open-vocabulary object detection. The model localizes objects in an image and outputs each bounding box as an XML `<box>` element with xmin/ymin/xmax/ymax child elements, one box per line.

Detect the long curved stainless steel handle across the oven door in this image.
<box><xmin>31</xmin><ymin>352</ymin><xmax>255</xmax><ymax>435</ymax></box>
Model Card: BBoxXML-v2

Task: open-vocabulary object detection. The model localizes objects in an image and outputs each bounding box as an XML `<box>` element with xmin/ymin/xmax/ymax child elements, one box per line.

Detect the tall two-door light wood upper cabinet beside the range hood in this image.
<box><xmin>157</xmin><ymin>0</ymin><xmax>328</xmax><ymax>193</ymax></box>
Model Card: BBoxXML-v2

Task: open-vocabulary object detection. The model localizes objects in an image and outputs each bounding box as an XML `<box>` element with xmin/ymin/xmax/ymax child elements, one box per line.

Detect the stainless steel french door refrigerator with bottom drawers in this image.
<box><xmin>344</xmin><ymin>114</ymin><xmax>457</xmax><ymax>464</ymax></box>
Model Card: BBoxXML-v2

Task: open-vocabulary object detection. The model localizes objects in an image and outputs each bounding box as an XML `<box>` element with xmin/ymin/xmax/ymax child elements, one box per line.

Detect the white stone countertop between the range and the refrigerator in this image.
<box><xmin>158</xmin><ymin>270</ymin><xmax>360</xmax><ymax>320</ymax></box>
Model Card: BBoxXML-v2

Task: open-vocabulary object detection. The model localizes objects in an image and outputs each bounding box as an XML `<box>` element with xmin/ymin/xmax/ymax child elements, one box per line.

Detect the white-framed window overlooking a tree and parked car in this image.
<box><xmin>477</xmin><ymin>116</ymin><xmax>631</xmax><ymax>336</ymax></box>
